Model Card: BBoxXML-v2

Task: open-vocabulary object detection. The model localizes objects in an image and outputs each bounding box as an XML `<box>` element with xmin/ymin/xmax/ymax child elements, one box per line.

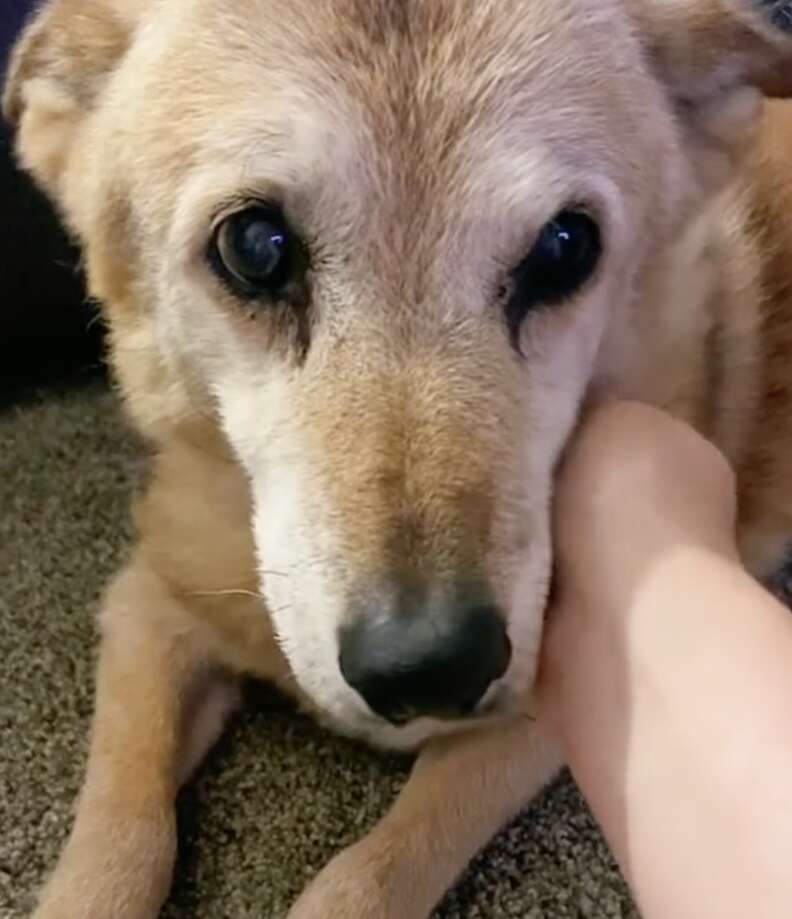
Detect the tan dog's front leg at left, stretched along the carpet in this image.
<box><xmin>34</xmin><ymin>563</ymin><xmax>236</xmax><ymax>919</ymax></box>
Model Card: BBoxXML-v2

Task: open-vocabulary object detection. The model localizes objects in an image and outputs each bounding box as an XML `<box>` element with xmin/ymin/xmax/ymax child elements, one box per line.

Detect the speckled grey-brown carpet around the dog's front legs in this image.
<box><xmin>0</xmin><ymin>383</ymin><xmax>636</xmax><ymax>919</ymax></box>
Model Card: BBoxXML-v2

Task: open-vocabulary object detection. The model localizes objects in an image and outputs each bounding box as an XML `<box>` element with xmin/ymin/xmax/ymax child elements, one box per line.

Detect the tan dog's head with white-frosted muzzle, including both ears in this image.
<box><xmin>6</xmin><ymin>0</ymin><xmax>792</xmax><ymax>745</ymax></box>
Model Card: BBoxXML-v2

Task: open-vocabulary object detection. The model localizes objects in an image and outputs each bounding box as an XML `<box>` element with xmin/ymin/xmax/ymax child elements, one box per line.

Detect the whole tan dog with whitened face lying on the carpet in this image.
<box><xmin>4</xmin><ymin>0</ymin><xmax>792</xmax><ymax>919</ymax></box>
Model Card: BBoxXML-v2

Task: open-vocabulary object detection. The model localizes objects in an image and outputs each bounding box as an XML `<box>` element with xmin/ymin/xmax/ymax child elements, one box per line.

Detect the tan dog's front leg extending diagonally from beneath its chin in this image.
<box><xmin>289</xmin><ymin>719</ymin><xmax>561</xmax><ymax>919</ymax></box>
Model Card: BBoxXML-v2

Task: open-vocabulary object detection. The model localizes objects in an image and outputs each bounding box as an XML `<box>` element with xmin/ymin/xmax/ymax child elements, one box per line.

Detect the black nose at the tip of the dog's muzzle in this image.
<box><xmin>340</xmin><ymin>591</ymin><xmax>511</xmax><ymax>724</ymax></box>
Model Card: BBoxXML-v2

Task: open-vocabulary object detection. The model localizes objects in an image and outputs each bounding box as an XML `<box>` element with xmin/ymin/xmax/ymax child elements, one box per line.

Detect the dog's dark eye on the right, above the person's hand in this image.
<box><xmin>506</xmin><ymin>210</ymin><xmax>602</xmax><ymax>338</ymax></box>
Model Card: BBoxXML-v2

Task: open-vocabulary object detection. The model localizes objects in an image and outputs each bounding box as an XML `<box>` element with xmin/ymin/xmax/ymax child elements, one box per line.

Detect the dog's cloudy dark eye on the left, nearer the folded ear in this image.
<box><xmin>210</xmin><ymin>205</ymin><xmax>297</xmax><ymax>297</ymax></box>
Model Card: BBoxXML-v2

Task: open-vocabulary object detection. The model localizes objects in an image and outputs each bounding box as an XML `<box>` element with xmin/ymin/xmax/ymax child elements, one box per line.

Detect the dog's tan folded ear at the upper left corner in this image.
<box><xmin>3</xmin><ymin>0</ymin><xmax>149</xmax><ymax>198</ymax></box>
